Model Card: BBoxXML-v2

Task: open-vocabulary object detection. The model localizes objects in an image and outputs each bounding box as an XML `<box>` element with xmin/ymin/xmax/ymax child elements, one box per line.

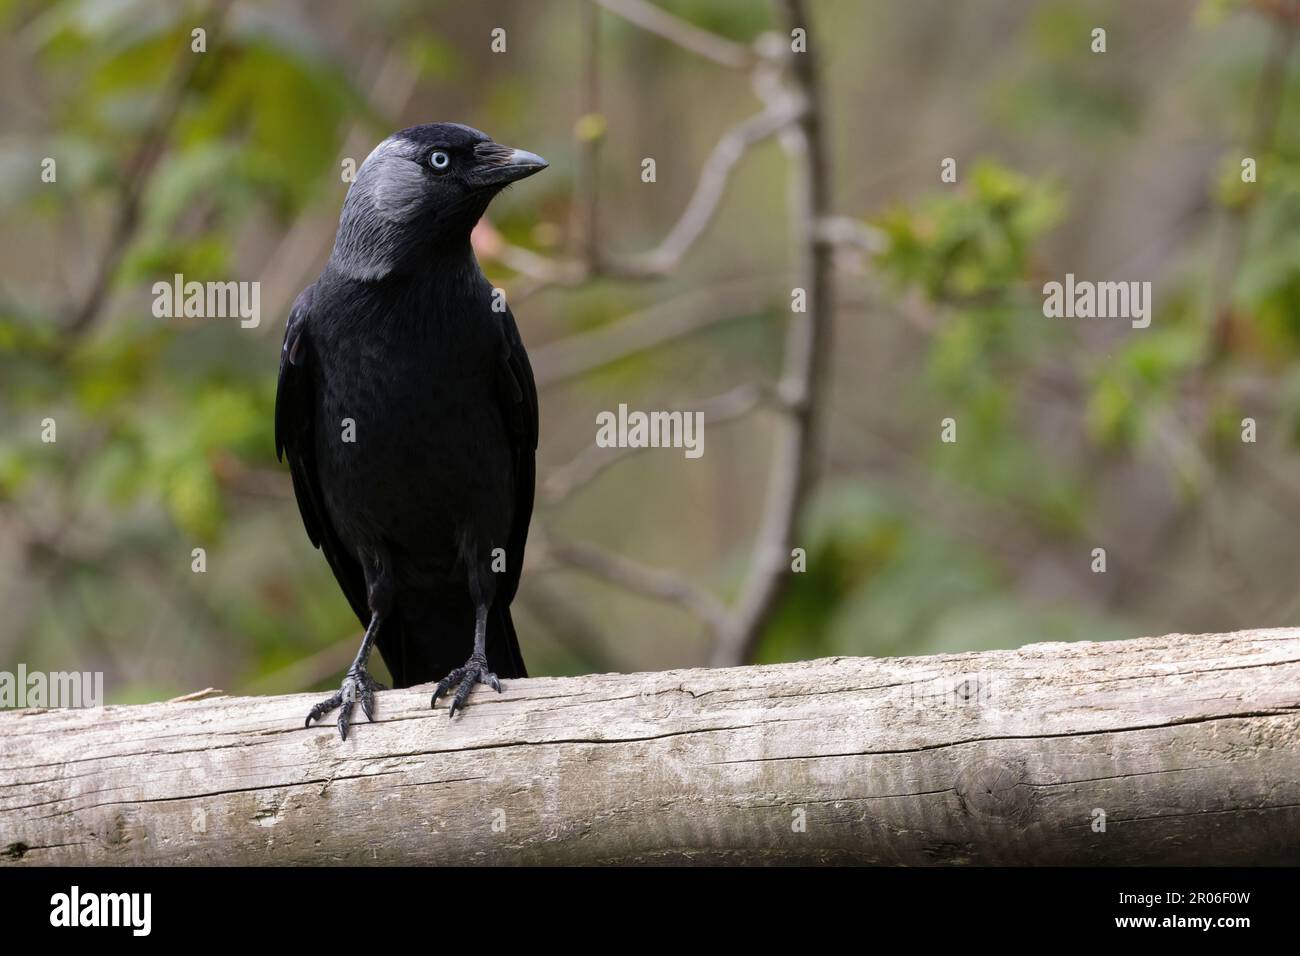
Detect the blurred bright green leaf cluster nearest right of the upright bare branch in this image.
<box><xmin>878</xmin><ymin>161</ymin><xmax>1083</xmax><ymax>531</ymax></box>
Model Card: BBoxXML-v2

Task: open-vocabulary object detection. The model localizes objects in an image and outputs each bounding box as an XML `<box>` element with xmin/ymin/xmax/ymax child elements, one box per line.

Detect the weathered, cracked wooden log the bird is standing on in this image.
<box><xmin>0</xmin><ymin>630</ymin><xmax>1300</xmax><ymax>864</ymax></box>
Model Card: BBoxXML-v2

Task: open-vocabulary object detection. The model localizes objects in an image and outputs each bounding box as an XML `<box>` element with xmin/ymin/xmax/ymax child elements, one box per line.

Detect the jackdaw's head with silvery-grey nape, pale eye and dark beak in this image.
<box><xmin>332</xmin><ymin>122</ymin><xmax>546</xmax><ymax>281</ymax></box>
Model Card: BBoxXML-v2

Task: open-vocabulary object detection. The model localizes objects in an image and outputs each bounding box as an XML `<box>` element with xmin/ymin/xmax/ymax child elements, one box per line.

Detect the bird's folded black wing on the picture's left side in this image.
<box><xmin>276</xmin><ymin>286</ymin><xmax>371</xmax><ymax>624</ymax></box>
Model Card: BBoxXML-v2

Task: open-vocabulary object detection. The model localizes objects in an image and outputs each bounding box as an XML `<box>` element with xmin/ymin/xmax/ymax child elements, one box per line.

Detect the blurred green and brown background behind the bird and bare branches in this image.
<box><xmin>0</xmin><ymin>0</ymin><xmax>1300</xmax><ymax>702</ymax></box>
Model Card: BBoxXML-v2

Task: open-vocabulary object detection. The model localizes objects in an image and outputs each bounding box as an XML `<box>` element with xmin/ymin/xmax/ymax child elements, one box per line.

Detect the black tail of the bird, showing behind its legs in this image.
<box><xmin>376</xmin><ymin>602</ymin><xmax>528</xmax><ymax>687</ymax></box>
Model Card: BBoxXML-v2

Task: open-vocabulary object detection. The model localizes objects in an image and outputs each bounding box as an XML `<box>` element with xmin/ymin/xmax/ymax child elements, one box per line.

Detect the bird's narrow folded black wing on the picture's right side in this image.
<box><xmin>497</xmin><ymin>308</ymin><xmax>537</xmax><ymax>606</ymax></box>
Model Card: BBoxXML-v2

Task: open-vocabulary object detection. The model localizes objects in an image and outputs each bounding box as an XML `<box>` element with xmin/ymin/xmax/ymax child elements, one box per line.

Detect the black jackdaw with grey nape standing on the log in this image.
<box><xmin>276</xmin><ymin>122</ymin><xmax>546</xmax><ymax>739</ymax></box>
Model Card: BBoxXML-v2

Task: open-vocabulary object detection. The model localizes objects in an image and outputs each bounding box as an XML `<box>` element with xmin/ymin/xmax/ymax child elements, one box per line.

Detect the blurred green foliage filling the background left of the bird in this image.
<box><xmin>0</xmin><ymin>0</ymin><xmax>390</xmax><ymax>700</ymax></box>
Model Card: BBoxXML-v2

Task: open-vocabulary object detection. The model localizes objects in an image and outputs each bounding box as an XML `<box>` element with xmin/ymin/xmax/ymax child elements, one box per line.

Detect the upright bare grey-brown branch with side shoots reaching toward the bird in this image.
<box><xmin>523</xmin><ymin>0</ymin><xmax>832</xmax><ymax>665</ymax></box>
